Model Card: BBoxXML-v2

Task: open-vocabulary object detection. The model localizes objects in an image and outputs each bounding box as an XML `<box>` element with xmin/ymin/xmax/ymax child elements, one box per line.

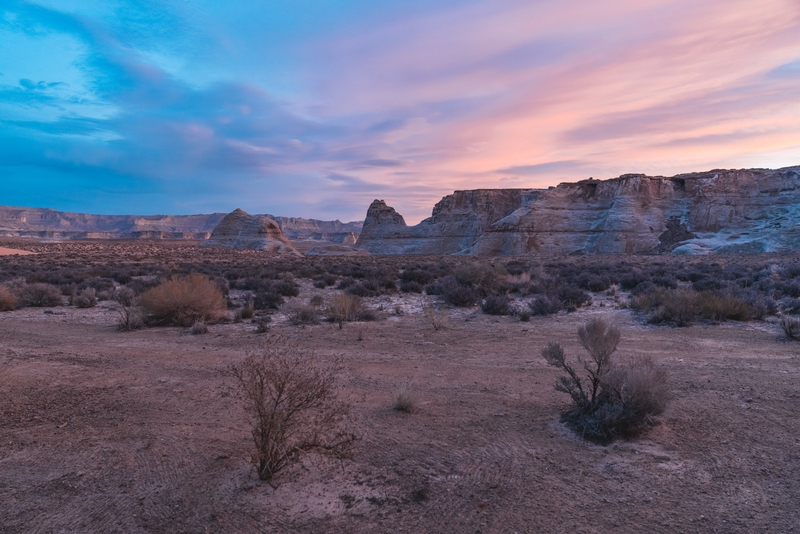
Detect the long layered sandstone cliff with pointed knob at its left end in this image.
<box><xmin>357</xmin><ymin>167</ymin><xmax>800</xmax><ymax>255</ymax></box>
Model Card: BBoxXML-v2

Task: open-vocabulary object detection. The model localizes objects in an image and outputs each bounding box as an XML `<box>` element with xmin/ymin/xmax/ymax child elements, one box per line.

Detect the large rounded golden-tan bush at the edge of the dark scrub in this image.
<box><xmin>139</xmin><ymin>273</ymin><xmax>228</xmax><ymax>326</ymax></box>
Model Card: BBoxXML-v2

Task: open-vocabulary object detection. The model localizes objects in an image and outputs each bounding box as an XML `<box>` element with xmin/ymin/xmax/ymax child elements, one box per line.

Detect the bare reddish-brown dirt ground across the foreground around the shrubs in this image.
<box><xmin>0</xmin><ymin>253</ymin><xmax>800</xmax><ymax>533</ymax></box>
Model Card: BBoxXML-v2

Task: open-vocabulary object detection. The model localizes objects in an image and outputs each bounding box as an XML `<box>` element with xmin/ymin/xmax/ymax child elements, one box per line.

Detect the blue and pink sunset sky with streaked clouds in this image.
<box><xmin>0</xmin><ymin>0</ymin><xmax>800</xmax><ymax>224</ymax></box>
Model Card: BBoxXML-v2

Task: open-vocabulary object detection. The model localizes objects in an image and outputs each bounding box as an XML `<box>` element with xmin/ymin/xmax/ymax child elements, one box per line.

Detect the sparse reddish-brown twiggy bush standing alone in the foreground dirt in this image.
<box><xmin>231</xmin><ymin>337</ymin><xmax>356</xmax><ymax>481</ymax></box>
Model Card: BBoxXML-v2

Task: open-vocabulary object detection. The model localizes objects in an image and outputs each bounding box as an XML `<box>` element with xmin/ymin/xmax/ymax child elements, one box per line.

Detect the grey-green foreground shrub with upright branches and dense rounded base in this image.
<box><xmin>542</xmin><ymin>319</ymin><xmax>670</xmax><ymax>443</ymax></box>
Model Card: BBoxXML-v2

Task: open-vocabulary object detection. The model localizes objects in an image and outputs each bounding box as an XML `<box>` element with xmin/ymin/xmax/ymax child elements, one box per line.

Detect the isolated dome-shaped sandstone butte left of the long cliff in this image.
<box><xmin>201</xmin><ymin>209</ymin><xmax>300</xmax><ymax>256</ymax></box>
